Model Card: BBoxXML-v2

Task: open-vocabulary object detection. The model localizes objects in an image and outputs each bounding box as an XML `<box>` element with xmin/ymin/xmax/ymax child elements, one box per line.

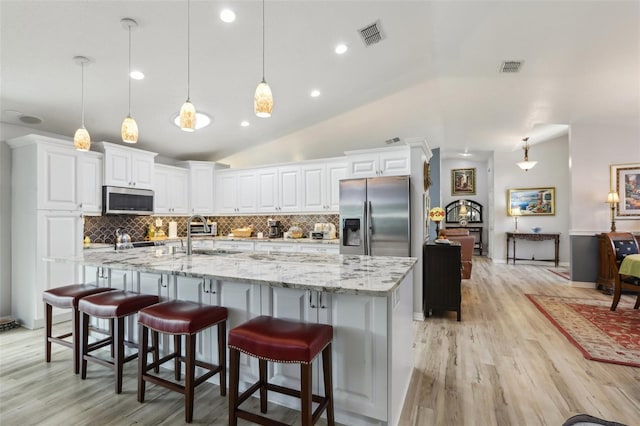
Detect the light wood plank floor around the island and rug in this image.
<box><xmin>0</xmin><ymin>257</ymin><xmax>640</xmax><ymax>426</ymax></box>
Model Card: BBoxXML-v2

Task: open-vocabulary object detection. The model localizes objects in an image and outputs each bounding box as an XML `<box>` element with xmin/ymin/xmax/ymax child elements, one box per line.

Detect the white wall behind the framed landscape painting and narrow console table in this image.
<box><xmin>489</xmin><ymin>135</ymin><xmax>568</xmax><ymax>263</ymax></box>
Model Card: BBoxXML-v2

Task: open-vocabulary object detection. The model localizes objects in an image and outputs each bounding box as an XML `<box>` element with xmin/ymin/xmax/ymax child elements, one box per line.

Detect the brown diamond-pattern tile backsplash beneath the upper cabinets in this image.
<box><xmin>84</xmin><ymin>214</ymin><xmax>339</xmax><ymax>244</ymax></box>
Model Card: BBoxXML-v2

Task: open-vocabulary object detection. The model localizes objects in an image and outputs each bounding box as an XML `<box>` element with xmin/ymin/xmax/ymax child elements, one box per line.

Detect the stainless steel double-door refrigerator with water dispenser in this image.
<box><xmin>340</xmin><ymin>176</ymin><xmax>411</xmax><ymax>256</ymax></box>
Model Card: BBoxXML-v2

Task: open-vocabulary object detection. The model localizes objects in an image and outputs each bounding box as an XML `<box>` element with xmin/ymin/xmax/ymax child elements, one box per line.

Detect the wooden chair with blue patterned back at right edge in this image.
<box><xmin>606</xmin><ymin>232</ymin><xmax>640</xmax><ymax>311</ymax></box>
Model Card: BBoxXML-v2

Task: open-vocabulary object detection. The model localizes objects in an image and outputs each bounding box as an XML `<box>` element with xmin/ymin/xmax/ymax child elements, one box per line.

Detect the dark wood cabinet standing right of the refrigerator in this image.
<box><xmin>422</xmin><ymin>244</ymin><xmax>462</xmax><ymax>321</ymax></box>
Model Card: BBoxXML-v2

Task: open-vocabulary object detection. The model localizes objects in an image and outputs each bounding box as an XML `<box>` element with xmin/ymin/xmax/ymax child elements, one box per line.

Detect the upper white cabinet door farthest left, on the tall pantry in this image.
<box><xmin>34</xmin><ymin>146</ymin><xmax>80</xmax><ymax>210</ymax></box>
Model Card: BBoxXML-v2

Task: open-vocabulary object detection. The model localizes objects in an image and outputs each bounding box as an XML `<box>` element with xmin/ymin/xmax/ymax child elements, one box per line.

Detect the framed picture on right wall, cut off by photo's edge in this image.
<box><xmin>609</xmin><ymin>164</ymin><xmax>640</xmax><ymax>219</ymax></box>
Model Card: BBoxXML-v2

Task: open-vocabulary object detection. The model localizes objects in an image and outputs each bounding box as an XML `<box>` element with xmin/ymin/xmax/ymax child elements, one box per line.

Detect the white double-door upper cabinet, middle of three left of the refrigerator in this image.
<box><xmin>257</xmin><ymin>166</ymin><xmax>301</xmax><ymax>213</ymax></box>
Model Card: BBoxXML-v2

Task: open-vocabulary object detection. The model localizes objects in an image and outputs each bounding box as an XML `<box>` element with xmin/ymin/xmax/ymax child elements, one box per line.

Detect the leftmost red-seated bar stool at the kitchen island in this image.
<box><xmin>42</xmin><ymin>284</ymin><xmax>112</xmax><ymax>374</ymax></box>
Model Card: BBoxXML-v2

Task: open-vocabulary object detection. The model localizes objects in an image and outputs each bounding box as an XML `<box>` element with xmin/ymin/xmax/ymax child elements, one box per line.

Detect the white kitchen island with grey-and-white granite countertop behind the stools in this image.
<box><xmin>48</xmin><ymin>247</ymin><xmax>416</xmax><ymax>425</ymax></box>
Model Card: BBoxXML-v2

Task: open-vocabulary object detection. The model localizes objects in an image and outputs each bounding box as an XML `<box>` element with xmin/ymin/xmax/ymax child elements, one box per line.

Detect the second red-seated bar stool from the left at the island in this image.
<box><xmin>78</xmin><ymin>290</ymin><xmax>159</xmax><ymax>393</ymax></box>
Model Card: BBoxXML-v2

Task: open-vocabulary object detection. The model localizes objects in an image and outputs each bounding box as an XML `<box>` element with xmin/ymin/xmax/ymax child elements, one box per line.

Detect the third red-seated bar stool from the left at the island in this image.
<box><xmin>138</xmin><ymin>300</ymin><xmax>227</xmax><ymax>423</ymax></box>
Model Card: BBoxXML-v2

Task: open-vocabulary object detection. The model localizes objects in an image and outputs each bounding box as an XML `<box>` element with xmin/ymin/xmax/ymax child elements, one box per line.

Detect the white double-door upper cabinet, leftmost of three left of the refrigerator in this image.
<box><xmin>216</xmin><ymin>169</ymin><xmax>257</xmax><ymax>214</ymax></box>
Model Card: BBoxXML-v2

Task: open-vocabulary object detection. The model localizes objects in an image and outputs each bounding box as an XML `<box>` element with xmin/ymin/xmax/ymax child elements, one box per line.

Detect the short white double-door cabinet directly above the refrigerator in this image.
<box><xmin>347</xmin><ymin>146</ymin><xmax>411</xmax><ymax>178</ymax></box>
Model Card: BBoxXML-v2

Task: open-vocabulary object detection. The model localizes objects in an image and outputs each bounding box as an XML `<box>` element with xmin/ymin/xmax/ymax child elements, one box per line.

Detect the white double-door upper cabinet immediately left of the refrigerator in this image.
<box><xmin>300</xmin><ymin>161</ymin><xmax>348</xmax><ymax>212</ymax></box>
